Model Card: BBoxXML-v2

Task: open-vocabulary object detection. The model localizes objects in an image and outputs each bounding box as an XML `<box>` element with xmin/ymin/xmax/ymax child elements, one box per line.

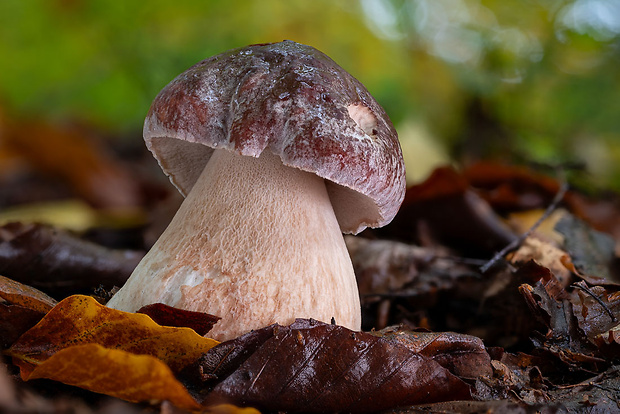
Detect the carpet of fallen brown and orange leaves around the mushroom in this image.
<box><xmin>0</xmin><ymin>155</ymin><xmax>620</xmax><ymax>412</ymax></box>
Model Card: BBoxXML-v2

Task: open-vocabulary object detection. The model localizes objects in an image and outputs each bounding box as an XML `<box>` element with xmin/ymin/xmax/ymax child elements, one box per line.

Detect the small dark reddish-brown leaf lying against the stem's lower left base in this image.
<box><xmin>136</xmin><ymin>303</ymin><xmax>222</xmax><ymax>336</ymax></box>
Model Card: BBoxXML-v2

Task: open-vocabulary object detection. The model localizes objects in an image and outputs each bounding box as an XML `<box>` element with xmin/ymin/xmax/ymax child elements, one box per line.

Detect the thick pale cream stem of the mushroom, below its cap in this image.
<box><xmin>108</xmin><ymin>149</ymin><xmax>361</xmax><ymax>340</ymax></box>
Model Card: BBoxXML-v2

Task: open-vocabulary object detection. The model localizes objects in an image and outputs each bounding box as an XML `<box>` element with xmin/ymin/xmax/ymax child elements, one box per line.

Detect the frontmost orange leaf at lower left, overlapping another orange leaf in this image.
<box><xmin>26</xmin><ymin>344</ymin><xmax>200</xmax><ymax>410</ymax></box>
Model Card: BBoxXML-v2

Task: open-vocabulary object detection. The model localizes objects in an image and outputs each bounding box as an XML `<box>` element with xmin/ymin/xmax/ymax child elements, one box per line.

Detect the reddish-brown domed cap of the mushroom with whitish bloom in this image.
<box><xmin>144</xmin><ymin>41</ymin><xmax>405</xmax><ymax>233</ymax></box>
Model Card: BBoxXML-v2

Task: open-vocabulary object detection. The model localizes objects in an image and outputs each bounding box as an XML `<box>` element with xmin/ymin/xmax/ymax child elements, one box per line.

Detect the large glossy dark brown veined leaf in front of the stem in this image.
<box><xmin>191</xmin><ymin>319</ymin><xmax>471</xmax><ymax>412</ymax></box>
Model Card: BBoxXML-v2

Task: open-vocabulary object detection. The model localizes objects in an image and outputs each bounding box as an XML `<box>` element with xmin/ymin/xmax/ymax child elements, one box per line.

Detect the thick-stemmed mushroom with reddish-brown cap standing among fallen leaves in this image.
<box><xmin>108</xmin><ymin>41</ymin><xmax>405</xmax><ymax>340</ymax></box>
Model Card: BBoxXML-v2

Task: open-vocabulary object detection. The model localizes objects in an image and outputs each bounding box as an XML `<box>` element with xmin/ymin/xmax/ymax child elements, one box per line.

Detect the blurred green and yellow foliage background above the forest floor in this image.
<box><xmin>0</xmin><ymin>0</ymin><xmax>620</xmax><ymax>190</ymax></box>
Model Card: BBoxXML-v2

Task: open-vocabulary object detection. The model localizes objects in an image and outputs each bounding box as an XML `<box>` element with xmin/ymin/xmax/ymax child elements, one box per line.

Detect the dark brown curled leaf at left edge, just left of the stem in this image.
<box><xmin>0</xmin><ymin>223</ymin><xmax>143</xmax><ymax>298</ymax></box>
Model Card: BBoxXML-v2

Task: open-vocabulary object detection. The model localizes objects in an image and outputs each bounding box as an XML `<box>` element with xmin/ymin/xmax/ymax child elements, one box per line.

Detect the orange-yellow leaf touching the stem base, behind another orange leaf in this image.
<box><xmin>6</xmin><ymin>295</ymin><xmax>218</xmax><ymax>376</ymax></box>
